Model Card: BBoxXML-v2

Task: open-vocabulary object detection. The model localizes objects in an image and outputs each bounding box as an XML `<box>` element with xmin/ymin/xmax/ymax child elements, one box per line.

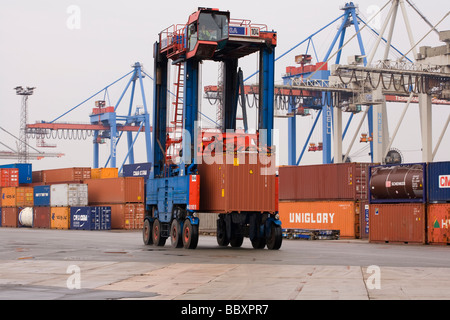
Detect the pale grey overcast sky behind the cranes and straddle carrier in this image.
<box><xmin>0</xmin><ymin>0</ymin><xmax>450</xmax><ymax>170</ymax></box>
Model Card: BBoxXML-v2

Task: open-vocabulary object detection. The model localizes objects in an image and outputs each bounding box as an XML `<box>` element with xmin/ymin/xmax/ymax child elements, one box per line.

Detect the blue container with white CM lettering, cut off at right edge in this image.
<box><xmin>428</xmin><ymin>162</ymin><xmax>450</xmax><ymax>202</ymax></box>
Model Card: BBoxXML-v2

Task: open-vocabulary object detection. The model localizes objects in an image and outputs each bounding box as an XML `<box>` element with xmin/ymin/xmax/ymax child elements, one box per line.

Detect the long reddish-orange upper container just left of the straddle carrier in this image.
<box><xmin>84</xmin><ymin>177</ymin><xmax>145</xmax><ymax>205</ymax></box>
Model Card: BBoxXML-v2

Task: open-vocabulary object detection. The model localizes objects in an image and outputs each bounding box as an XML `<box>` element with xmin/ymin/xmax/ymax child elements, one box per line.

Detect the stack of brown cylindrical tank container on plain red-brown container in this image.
<box><xmin>369</xmin><ymin>163</ymin><xmax>427</xmax><ymax>244</ymax></box>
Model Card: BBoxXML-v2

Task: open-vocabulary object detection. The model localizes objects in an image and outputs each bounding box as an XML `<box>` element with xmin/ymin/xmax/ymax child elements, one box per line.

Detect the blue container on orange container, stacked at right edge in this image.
<box><xmin>427</xmin><ymin>162</ymin><xmax>450</xmax><ymax>245</ymax></box>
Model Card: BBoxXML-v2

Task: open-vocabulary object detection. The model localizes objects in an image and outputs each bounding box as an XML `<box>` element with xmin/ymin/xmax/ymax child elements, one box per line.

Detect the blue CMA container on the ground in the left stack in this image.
<box><xmin>70</xmin><ymin>207</ymin><xmax>111</xmax><ymax>230</ymax></box>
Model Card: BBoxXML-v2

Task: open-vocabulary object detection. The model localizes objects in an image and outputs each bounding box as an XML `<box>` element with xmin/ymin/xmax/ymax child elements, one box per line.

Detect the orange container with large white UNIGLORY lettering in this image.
<box><xmin>279</xmin><ymin>201</ymin><xmax>360</xmax><ymax>238</ymax></box>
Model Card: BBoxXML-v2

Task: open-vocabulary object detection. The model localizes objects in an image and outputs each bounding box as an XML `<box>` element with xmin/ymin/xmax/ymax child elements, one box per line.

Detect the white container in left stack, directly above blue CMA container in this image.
<box><xmin>50</xmin><ymin>184</ymin><xmax>88</xmax><ymax>207</ymax></box>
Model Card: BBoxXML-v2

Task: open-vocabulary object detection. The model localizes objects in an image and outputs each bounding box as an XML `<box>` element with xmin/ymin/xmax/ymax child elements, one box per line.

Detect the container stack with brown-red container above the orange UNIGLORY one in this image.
<box><xmin>278</xmin><ymin>163</ymin><xmax>370</xmax><ymax>239</ymax></box>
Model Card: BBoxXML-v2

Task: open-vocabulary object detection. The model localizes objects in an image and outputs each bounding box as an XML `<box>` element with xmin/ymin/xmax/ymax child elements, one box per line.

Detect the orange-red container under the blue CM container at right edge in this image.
<box><xmin>427</xmin><ymin>203</ymin><xmax>450</xmax><ymax>245</ymax></box>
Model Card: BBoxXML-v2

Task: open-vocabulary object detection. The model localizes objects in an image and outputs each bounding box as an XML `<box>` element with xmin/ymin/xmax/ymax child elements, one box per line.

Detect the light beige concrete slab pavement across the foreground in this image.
<box><xmin>0</xmin><ymin>259</ymin><xmax>450</xmax><ymax>300</ymax></box>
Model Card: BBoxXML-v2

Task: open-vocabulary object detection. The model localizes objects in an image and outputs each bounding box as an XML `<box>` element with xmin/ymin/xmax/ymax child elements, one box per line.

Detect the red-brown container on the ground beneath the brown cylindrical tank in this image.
<box><xmin>369</xmin><ymin>203</ymin><xmax>426</xmax><ymax>244</ymax></box>
